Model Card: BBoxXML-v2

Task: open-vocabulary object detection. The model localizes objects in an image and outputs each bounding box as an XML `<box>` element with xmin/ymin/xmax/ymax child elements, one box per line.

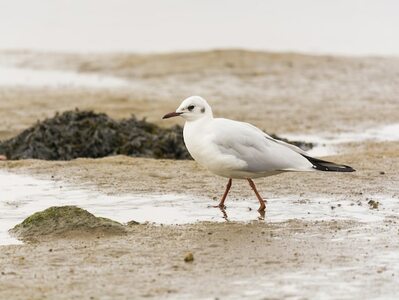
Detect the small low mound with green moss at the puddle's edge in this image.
<box><xmin>10</xmin><ymin>206</ymin><xmax>126</xmax><ymax>241</ymax></box>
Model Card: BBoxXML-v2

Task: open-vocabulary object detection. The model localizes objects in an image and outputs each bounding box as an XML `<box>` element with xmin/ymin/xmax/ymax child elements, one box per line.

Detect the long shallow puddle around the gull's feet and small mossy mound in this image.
<box><xmin>0</xmin><ymin>171</ymin><xmax>399</xmax><ymax>244</ymax></box>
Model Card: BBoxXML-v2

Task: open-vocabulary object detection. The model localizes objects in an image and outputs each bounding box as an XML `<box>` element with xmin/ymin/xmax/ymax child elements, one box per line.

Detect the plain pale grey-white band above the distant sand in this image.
<box><xmin>0</xmin><ymin>0</ymin><xmax>399</xmax><ymax>55</ymax></box>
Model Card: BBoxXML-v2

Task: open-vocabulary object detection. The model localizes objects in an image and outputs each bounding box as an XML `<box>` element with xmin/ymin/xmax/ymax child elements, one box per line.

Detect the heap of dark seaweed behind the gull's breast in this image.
<box><xmin>0</xmin><ymin>110</ymin><xmax>191</xmax><ymax>160</ymax></box>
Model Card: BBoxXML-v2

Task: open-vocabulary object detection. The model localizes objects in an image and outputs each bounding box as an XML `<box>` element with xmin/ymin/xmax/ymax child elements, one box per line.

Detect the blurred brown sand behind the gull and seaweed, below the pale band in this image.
<box><xmin>0</xmin><ymin>50</ymin><xmax>399</xmax><ymax>138</ymax></box>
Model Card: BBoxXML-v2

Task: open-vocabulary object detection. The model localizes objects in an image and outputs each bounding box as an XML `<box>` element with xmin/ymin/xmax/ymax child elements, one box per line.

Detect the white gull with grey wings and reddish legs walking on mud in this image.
<box><xmin>163</xmin><ymin>96</ymin><xmax>355</xmax><ymax>213</ymax></box>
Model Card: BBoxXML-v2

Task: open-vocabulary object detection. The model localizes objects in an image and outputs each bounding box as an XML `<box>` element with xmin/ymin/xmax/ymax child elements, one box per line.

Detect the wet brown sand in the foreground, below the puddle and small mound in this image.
<box><xmin>0</xmin><ymin>221</ymin><xmax>399</xmax><ymax>299</ymax></box>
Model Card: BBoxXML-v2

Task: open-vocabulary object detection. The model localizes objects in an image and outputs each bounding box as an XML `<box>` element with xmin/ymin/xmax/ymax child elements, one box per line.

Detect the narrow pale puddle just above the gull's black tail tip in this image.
<box><xmin>279</xmin><ymin>123</ymin><xmax>399</xmax><ymax>156</ymax></box>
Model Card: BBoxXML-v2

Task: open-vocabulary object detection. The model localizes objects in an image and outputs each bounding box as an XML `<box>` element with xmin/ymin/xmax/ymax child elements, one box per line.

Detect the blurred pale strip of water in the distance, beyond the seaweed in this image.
<box><xmin>0</xmin><ymin>66</ymin><xmax>129</xmax><ymax>88</ymax></box>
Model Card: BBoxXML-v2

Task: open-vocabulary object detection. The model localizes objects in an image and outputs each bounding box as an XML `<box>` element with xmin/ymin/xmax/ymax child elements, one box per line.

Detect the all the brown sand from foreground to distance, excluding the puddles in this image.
<box><xmin>0</xmin><ymin>51</ymin><xmax>399</xmax><ymax>299</ymax></box>
